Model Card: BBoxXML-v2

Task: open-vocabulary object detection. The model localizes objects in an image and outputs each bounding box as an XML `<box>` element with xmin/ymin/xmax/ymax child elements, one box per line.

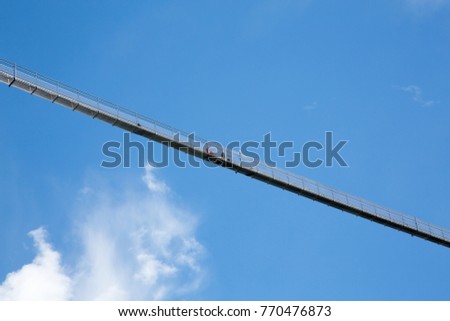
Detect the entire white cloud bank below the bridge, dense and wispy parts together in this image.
<box><xmin>0</xmin><ymin>168</ymin><xmax>204</xmax><ymax>300</ymax></box>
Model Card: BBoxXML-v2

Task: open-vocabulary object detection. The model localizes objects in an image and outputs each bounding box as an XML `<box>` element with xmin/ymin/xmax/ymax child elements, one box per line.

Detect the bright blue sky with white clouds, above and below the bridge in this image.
<box><xmin>0</xmin><ymin>0</ymin><xmax>450</xmax><ymax>300</ymax></box>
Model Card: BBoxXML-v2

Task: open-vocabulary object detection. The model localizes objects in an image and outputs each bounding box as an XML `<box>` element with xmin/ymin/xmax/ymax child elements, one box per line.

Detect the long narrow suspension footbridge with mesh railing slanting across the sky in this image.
<box><xmin>0</xmin><ymin>59</ymin><xmax>450</xmax><ymax>247</ymax></box>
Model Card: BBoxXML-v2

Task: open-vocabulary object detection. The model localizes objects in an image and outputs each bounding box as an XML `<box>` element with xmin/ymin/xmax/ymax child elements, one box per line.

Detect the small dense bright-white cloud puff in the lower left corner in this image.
<box><xmin>0</xmin><ymin>228</ymin><xmax>72</xmax><ymax>300</ymax></box>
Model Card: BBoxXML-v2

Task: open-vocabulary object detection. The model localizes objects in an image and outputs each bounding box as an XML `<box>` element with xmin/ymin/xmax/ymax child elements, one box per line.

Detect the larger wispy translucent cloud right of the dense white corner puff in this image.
<box><xmin>75</xmin><ymin>168</ymin><xmax>202</xmax><ymax>299</ymax></box>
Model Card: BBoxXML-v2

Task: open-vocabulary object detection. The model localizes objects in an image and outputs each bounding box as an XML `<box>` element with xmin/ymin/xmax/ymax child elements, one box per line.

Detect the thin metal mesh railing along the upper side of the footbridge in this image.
<box><xmin>0</xmin><ymin>59</ymin><xmax>450</xmax><ymax>242</ymax></box>
